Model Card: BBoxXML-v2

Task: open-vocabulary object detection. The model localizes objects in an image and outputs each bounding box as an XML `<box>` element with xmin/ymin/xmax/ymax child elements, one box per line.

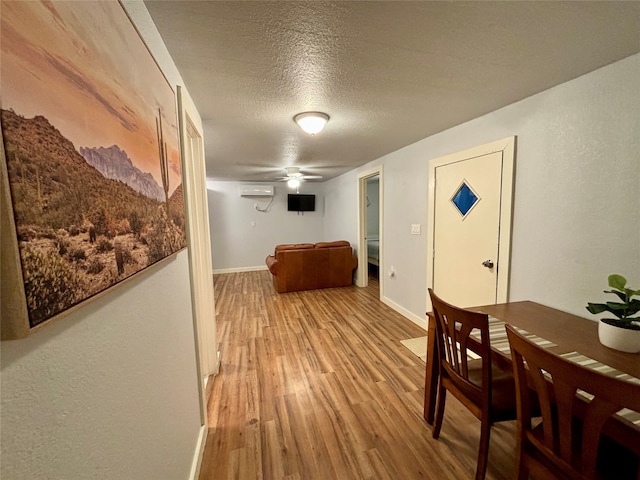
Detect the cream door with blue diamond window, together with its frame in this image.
<box><xmin>427</xmin><ymin>141</ymin><xmax>513</xmax><ymax>307</ymax></box>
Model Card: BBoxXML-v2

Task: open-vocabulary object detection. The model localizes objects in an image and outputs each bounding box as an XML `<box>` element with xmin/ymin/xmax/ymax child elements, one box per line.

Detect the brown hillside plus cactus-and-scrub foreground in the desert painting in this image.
<box><xmin>1</xmin><ymin>109</ymin><xmax>186</xmax><ymax>327</ymax></box>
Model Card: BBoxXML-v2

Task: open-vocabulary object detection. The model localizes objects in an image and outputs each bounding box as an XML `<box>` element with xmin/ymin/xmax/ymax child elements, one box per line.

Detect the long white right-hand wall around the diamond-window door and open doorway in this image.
<box><xmin>325</xmin><ymin>55</ymin><xmax>640</xmax><ymax>324</ymax></box>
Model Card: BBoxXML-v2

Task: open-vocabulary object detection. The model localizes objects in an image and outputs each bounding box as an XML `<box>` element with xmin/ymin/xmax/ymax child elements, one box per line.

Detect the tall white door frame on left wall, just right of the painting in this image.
<box><xmin>178</xmin><ymin>86</ymin><xmax>218</xmax><ymax>426</ymax></box>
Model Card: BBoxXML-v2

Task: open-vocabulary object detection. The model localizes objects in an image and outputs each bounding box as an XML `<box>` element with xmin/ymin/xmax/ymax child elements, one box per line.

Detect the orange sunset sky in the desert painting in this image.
<box><xmin>0</xmin><ymin>0</ymin><xmax>181</xmax><ymax>193</ymax></box>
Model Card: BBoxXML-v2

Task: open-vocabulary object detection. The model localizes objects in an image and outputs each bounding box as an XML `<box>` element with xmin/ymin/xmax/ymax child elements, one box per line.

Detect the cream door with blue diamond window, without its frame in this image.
<box><xmin>433</xmin><ymin>152</ymin><xmax>502</xmax><ymax>307</ymax></box>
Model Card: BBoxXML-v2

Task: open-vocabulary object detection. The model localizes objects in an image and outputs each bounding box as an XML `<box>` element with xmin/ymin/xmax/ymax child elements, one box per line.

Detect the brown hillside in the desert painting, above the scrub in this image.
<box><xmin>2</xmin><ymin>110</ymin><xmax>159</xmax><ymax>229</ymax></box>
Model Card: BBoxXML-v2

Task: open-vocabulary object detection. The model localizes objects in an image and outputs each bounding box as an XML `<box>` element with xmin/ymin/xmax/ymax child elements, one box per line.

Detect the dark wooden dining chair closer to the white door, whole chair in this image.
<box><xmin>429</xmin><ymin>288</ymin><xmax>516</xmax><ymax>480</ymax></box>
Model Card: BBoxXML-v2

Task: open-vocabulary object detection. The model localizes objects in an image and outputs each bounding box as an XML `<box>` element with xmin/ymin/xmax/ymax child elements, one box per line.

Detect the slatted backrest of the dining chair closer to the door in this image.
<box><xmin>429</xmin><ymin>289</ymin><xmax>491</xmax><ymax>408</ymax></box>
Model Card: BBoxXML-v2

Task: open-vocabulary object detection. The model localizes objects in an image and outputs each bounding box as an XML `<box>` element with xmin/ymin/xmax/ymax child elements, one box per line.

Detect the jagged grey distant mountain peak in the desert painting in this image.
<box><xmin>80</xmin><ymin>145</ymin><xmax>164</xmax><ymax>201</ymax></box>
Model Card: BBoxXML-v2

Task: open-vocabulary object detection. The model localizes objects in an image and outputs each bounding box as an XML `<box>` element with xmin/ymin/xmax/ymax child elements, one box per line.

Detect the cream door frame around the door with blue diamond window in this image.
<box><xmin>427</xmin><ymin>136</ymin><xmax>516</xmax><ymax>312</ymax></box>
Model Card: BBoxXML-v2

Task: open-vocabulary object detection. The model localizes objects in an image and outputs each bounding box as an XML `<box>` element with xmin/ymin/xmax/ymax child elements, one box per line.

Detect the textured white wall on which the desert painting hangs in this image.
<box><xmin>0</xmin><ymin>1</ymin><xmax>201</xmax><ymax>480</ymax></box>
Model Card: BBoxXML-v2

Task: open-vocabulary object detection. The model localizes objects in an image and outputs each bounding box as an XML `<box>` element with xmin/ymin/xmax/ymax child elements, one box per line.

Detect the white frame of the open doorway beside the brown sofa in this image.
<box><xmin>356</xmin><ymin>165</ymin><xmax>384</xmax><ymax>298</ymax></box>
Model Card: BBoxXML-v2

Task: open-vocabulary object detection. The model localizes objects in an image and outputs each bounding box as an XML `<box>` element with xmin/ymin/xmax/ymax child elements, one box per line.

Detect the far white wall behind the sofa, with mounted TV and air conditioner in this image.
<box><xmin>207</xmin><ymin>180</ymin><xmax>326</xmax><ymax>273</ymax></box>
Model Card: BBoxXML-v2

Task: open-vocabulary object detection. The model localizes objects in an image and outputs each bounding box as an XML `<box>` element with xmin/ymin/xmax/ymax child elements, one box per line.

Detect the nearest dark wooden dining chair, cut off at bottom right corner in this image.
<box><xmin>506</xmin><ymin>325</ymin><xmax>640</xmax><ymax>480</ymax></box>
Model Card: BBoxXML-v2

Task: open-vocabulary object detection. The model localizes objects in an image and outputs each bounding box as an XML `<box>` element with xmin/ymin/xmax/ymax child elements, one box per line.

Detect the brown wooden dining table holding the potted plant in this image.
<box><xmin>424</xmin><ymin>301</ymin><xmax>640</xmax><ymax>455</ymax></box>
